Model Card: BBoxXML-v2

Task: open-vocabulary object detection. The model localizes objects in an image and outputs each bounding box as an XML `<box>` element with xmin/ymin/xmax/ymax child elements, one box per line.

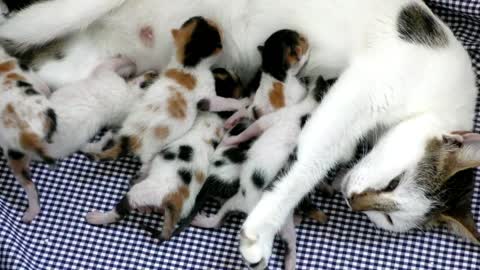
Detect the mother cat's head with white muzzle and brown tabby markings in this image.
<box><xmin>344</xmin><ymin>132</ymin><xmax>480</xmax><ymax>244</ymax></box>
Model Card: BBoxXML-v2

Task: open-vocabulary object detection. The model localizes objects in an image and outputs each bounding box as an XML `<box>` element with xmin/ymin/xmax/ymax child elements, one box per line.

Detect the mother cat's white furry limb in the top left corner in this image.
<box><xmin>0</xmin><ymin>0</ymin><xmax>126</xmax><ymax>51</ymax></box>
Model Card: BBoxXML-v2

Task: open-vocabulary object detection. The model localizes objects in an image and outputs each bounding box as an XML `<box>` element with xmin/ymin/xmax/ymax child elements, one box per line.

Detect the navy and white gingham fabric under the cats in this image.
<box><xmin>0</xmin><ymin>0</ymin><xmax>480</xmax><ymax>270</ymax></box>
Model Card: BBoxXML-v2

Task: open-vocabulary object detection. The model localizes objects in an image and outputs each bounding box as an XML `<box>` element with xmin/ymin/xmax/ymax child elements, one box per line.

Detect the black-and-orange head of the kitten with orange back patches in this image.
<box><xmin>172</xmin><ymin>16</ymin><xmax>223</xmax><ymax>67</ymax></box>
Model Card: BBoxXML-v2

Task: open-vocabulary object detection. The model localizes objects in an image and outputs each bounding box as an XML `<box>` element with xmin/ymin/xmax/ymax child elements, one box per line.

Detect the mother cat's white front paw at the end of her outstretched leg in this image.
<box><xmin>240</xmin><ymin>228</ymin><xmax>273</xmax><ymax>270</ymax></box>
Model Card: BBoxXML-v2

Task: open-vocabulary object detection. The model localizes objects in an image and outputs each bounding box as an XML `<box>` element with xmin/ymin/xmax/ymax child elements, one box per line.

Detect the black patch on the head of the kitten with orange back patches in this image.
<box><xmin>182</xmin><ymin>16</ymin><xmax>223</xmax><ymax>67</ymax></box>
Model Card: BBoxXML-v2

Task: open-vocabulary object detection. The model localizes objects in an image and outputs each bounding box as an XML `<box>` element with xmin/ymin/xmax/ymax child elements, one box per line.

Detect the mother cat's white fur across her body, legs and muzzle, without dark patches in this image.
<box><xmin>0</xmin><ymin>0</ymin><xmax>477</xmax><ymax>263</ymax></box>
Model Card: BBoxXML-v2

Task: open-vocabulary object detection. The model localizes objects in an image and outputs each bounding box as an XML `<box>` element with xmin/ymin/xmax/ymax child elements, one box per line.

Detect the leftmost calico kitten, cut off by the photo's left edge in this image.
<box><xmin>0</xmin><ymin>48</ymin><xmax>56</xmax><ymax>222</ymax></box>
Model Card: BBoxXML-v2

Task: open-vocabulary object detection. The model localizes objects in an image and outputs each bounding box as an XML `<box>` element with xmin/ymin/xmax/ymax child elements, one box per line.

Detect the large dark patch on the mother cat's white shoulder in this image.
<box><xmin>397</xmin><ymin>3</ymin><xmax>448</xmax><ymax>48</ymax></box>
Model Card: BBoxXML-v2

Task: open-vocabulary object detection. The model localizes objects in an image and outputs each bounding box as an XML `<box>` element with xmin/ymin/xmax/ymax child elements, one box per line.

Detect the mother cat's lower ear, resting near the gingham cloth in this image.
<box><xmin>439</xmin><ymin>209</ymin><xmax>480</xmax><ymax>245</ymax></box>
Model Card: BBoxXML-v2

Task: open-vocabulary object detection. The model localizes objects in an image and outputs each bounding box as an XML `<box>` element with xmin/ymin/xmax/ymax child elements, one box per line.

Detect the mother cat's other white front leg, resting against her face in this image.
<box><xmin>342</xmin><ymin>115</ymin><xmax>442</xmax><ymax>200</ymax></box>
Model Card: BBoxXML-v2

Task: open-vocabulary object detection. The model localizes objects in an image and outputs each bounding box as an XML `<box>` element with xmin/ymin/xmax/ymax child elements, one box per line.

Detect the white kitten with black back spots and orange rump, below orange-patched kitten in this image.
<box><xmin>86</xmin><ymin>69</ymin><xmax>242</xmax><ymax>240</ymax></box>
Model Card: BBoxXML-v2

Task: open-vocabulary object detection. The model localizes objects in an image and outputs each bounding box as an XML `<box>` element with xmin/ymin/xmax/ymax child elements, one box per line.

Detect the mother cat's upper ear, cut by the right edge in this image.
<box><xmin>443</xmin><ymin>131</ymin><xmax>480</xmax><ymax>172</ymax></box>
